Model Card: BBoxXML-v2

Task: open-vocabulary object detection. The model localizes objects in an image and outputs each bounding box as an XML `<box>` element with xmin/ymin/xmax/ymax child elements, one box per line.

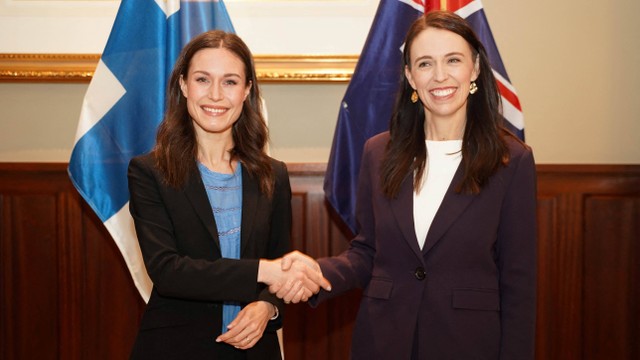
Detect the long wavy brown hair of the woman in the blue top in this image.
<box><xmin>153</xmin><ymin>30</ymin><xmax>275</xmax><ymax>196</ymax></box>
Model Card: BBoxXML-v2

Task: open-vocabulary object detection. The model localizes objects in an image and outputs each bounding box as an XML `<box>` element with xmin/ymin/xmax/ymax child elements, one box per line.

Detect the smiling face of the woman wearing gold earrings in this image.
<box><xmin>405</xmin><ymin>28</ymin><xmax>479</xmax><ymax>124</ymax></box>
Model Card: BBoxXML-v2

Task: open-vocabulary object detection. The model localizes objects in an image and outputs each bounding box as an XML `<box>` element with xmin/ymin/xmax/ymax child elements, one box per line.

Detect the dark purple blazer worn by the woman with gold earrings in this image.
<box><xmin>311</xmin><ymin>132</ymin><xmax>536</xmax><ymax>360</ymax></box>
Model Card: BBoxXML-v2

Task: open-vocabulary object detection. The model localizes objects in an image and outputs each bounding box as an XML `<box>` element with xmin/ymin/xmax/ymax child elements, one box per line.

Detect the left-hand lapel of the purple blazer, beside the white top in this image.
<box><xmin>390</xmin><ymin>176</ymin><xmax>422</xmax><ymax>259</ymax></box>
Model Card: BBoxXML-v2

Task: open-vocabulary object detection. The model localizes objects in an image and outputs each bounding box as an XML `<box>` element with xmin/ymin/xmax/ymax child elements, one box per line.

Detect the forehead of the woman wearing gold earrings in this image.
<box><xmin>410</xmin><ymin>27</ymin><xmax>471</xmax><ymax>59</ymax></box>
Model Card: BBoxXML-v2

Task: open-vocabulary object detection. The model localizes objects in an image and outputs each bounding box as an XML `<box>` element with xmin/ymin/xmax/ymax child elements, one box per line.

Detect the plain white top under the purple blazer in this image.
<box><xmin>413</xmin><ymin>140</ymin><xmax>462</xmax><ymax>249</ymax></box>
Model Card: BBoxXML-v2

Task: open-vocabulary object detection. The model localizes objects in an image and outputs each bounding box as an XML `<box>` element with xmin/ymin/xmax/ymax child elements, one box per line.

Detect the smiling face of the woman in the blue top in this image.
<box><xmin>180</xmin><ymin>48</ymin><xmax>251</xmax><ymax>142</ymax></box>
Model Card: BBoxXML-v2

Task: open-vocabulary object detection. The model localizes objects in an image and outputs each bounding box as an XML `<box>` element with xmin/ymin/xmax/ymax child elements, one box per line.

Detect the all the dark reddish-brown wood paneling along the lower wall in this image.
<box><xmin>0</xmin><ymin>163</ymin><xmax>640</xmax><ymax>360</ymax></box>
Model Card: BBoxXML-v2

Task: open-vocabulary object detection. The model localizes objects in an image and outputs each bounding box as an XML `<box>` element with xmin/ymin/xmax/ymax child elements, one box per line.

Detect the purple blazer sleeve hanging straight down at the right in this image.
<box><xmin>497</xmin><ymin>143</ymin><xmax>537</xmax><ymax>359</ymax></box>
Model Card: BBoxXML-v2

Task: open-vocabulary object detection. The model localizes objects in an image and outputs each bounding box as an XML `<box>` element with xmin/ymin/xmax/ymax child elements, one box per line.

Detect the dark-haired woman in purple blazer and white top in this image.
<box><xmin>277</xmin><ymin>11</ymin><xmax>536</xmax><ymax>360</ymax></box>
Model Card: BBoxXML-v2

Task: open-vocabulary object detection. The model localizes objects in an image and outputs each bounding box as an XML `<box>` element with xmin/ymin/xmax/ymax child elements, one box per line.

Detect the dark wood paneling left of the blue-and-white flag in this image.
<box><xmin>0</xmin><ymin>164</ymin><xmax>144</xmax><ymax>360</ymax></box>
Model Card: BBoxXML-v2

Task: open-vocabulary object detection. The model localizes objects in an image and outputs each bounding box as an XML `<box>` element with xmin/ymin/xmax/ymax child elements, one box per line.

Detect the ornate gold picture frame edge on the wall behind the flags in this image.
<box><xmin>0</xmin><ymin>53</ymin><xmax>358</xmax><ymax>83</ymax></box>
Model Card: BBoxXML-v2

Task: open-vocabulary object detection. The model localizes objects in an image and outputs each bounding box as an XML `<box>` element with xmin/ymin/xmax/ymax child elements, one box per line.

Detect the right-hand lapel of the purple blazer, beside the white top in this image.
<box><xmin>422</xmin><ymin>164</ymin><xmax>475</xmax><ymax>253</ymax></box>
